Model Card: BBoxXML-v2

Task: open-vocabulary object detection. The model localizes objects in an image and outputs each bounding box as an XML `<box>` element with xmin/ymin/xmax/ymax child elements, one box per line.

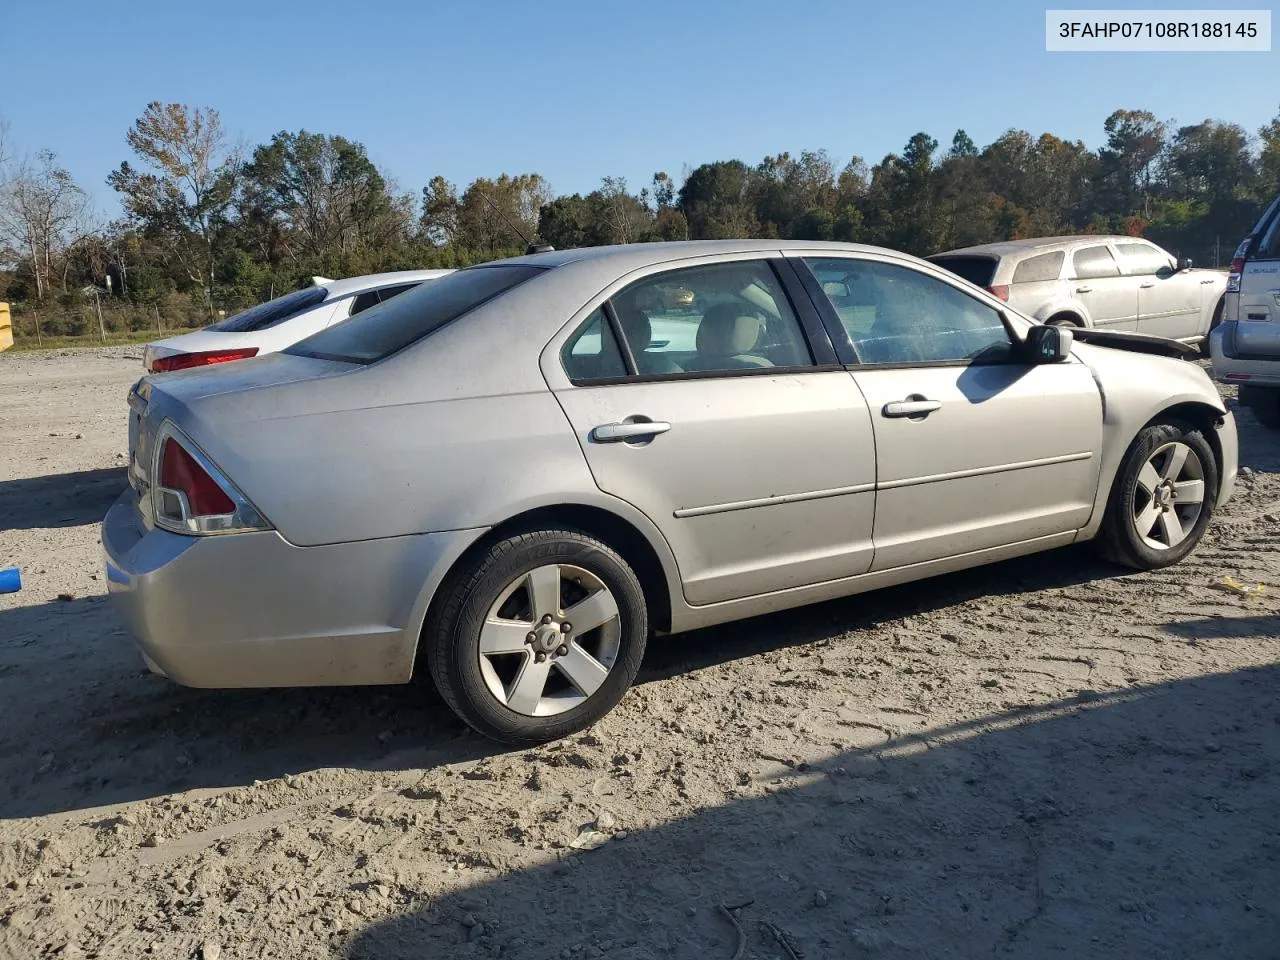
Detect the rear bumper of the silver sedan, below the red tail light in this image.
<box><xmin>102</xmin><ymin>490</ymin><xmax>483</xmax><ymax>687</ymax></box>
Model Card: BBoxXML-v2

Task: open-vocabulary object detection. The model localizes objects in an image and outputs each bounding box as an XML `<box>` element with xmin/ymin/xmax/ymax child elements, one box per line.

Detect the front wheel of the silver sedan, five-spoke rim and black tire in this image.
<box><xmin>1097</xmin><ymin>420</ymin><xmax>1219</xmax><ymax>570</ymax></box>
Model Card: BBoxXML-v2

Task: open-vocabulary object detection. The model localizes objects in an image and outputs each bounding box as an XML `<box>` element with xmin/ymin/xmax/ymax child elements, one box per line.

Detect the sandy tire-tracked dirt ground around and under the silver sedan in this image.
<box><xmin>0</xmin><ymin>348</ymin><xmax>1280</xmax><ymax>960</ymax></box>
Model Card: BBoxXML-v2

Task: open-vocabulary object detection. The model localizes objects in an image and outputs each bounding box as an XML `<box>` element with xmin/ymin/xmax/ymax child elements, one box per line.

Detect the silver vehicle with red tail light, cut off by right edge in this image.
<box><xmin>1210</xmin><ymin>197</ymin><xmax>1280</xmax><ymax>429</ymax></box>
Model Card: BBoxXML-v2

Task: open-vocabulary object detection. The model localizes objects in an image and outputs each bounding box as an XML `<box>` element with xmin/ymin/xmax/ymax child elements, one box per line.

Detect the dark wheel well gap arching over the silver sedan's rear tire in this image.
<box><xmin>415</xmin><ymin>503</ymin><xmax>671</xmax><ymax>673</ymax></box>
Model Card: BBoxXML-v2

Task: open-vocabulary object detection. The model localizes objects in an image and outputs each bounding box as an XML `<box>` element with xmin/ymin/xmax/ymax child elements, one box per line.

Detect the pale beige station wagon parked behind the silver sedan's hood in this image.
<box><xmin>929</xmin><ymin>236</ymin><xmax>1226</xmax><ymax>343</ymax></box>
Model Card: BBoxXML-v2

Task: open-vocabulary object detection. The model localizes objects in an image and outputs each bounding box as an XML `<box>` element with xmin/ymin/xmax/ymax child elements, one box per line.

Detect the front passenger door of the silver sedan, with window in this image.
<box><xmin>797</xmin><ymin>255</ymin><xmax>1102</xmax><ymax>570</ymax></box>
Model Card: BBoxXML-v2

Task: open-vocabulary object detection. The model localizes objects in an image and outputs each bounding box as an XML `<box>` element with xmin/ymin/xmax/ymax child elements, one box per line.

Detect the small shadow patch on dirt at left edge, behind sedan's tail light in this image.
<box><xmin>0</xmin><ymin>467</ymin><xmax>128</xmax><ymax>535</ymax></box>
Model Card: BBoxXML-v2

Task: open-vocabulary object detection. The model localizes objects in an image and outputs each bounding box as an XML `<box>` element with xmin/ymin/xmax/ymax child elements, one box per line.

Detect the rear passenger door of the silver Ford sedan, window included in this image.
<box><xmin>543</xmin><ymin>259</ymin><xmax>876</xmax><ymax>604</ymax></box>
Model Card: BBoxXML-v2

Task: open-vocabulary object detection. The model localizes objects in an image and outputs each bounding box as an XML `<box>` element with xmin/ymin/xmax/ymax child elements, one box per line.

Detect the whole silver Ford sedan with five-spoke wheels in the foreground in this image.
<box><xmin>102</xmin><ymin>241</ymin><xmax>1236</xmax><ymax>744</ymax></box>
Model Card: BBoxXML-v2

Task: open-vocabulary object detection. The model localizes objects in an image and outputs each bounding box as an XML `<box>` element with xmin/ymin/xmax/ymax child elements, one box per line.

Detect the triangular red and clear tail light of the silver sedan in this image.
<box><xmin>151</xmin><ymin>421</ymin><xmax>270</xmax><ymax>535</ymax></box>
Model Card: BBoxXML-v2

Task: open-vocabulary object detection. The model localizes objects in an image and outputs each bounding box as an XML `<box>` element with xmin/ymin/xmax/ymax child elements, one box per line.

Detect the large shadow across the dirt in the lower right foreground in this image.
<box><xmin>346</xmin><ymin>666</ymin><xmax>1280</xmax><ymax>960</ymax></box>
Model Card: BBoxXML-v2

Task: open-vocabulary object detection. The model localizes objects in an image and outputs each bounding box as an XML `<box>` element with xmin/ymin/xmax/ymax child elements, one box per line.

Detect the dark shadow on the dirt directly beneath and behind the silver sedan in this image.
<box><xmin>0</xmin><ymin>548</ymin><xmax>1120</xmax><ymax>817</ymax></box>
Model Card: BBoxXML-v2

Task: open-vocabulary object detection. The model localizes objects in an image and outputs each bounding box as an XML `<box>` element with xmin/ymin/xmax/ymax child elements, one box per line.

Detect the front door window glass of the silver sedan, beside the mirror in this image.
<box><xmin>805</xmin><ymin>259</ymin><xmax>1011</xmax><ymax>364</ymax></box>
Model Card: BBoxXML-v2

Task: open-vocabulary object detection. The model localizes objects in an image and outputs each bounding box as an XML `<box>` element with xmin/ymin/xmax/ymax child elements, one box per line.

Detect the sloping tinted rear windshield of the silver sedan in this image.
<box><xmin>284</xmin><ymin>265</ymin><xmax>545</xmax><ymax>364</ymax></box>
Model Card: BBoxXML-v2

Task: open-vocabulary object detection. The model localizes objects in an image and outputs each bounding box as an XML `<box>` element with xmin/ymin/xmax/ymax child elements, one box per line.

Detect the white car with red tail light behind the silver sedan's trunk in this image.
<box><xmin>142</xmin><ymin>270</ymin><xmax>453</xmax><ymax>374</ymax></box>
